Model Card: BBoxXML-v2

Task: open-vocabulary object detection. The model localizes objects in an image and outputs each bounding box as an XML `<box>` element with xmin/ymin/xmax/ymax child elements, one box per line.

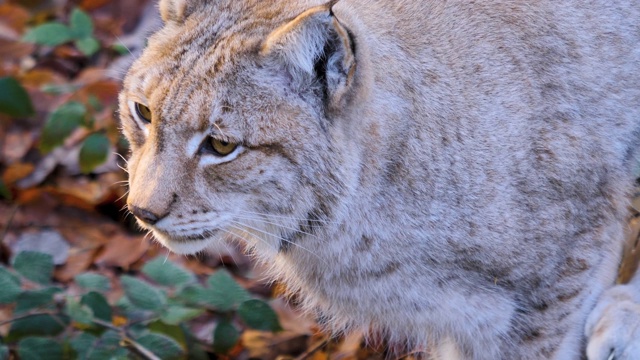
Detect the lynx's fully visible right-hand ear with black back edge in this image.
<box><xmin>261</xmin><ymin>2</ymin><xmax>356</xmax><ymax>107</ymax></box>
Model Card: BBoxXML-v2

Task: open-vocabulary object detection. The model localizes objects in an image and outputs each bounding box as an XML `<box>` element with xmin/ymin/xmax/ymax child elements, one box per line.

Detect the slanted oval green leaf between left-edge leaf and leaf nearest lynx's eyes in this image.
<box><xmin>40</xmin><ymin>101</ymin><xmax>87</xmax><ymax>153</ymax></box>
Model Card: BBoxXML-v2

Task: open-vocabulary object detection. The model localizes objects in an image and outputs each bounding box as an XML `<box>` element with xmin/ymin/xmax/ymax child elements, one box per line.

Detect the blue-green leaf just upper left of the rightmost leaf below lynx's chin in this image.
<box><xmin>207</xmin><ymin>269</ymin><xmax>251</xmax><ymax>311</ymax></box>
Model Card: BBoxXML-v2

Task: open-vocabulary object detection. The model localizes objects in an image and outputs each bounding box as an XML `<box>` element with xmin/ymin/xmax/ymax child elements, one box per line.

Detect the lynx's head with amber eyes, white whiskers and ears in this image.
<box><xmin>120</xmin><ymin>0</ymin><xmax>357</xmax><ymax>254</ymax></box>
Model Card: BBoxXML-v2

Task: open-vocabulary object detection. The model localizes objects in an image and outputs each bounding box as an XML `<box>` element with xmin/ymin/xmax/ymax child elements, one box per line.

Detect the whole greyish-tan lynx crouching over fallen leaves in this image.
<box><xmin>120</xmin><ymin>0</ymin><xmax>640</xmax><ymax>360</ymax></box>
